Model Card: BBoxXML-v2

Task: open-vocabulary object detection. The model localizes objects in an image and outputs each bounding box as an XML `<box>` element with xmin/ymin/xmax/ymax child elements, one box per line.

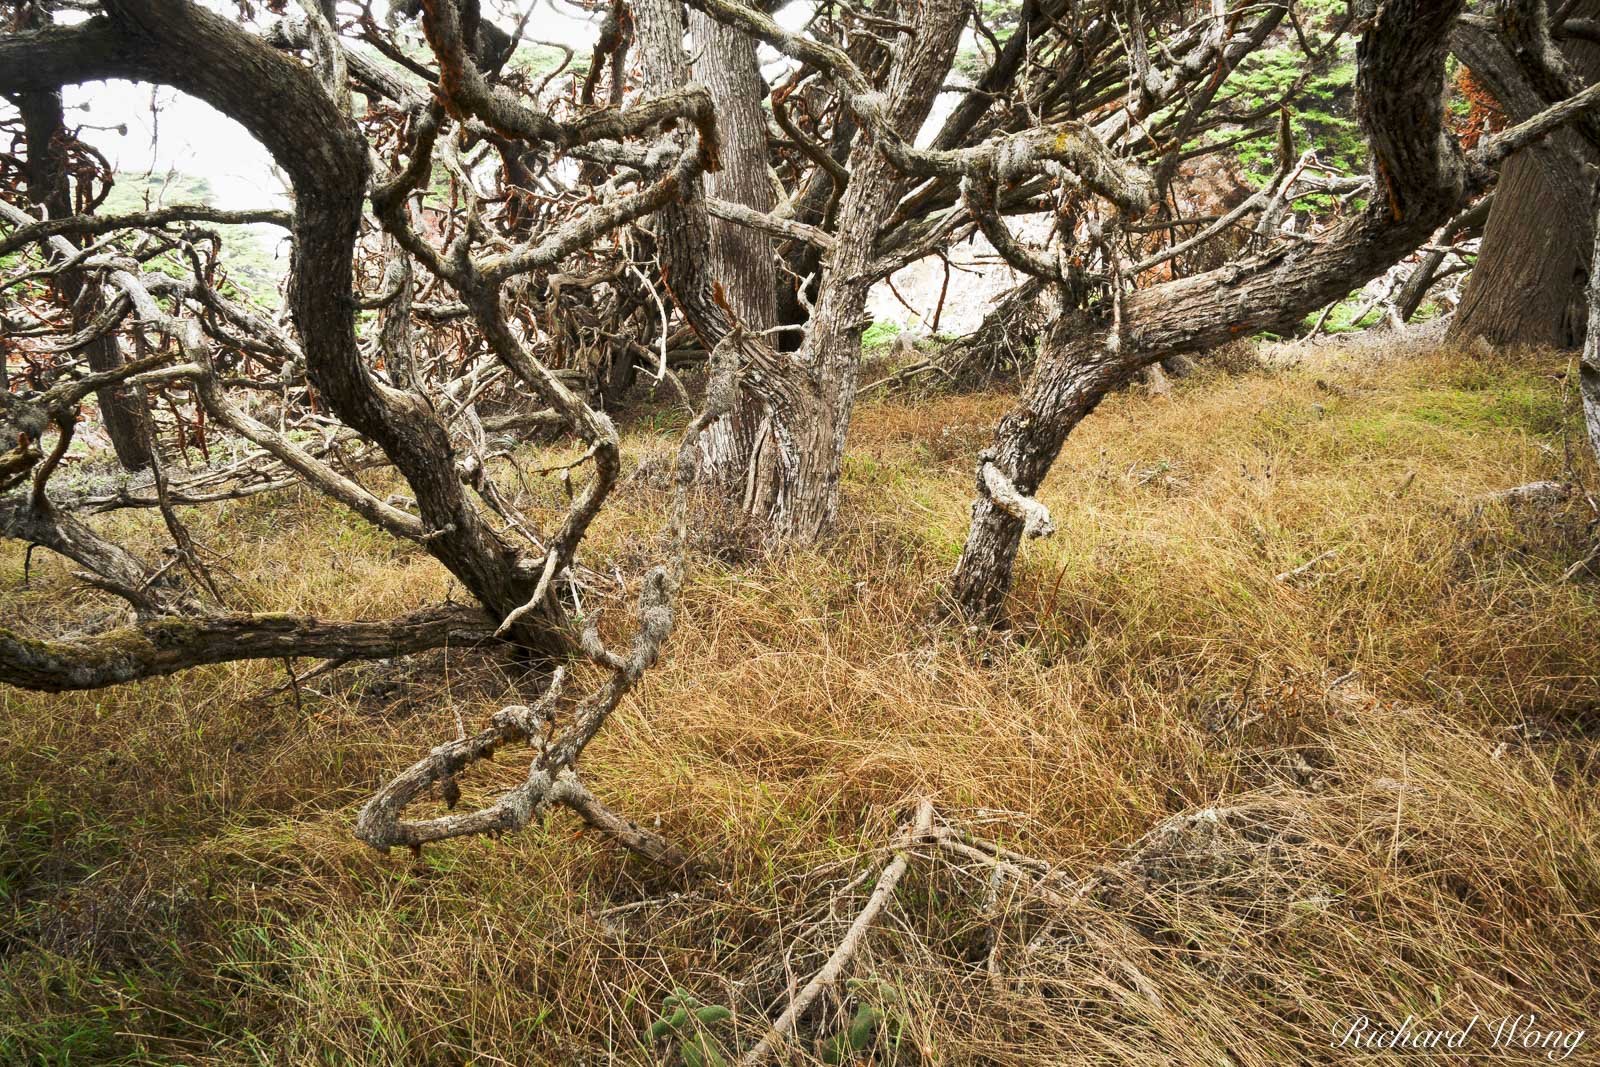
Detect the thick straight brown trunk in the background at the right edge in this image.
<box><xmin>1448</xmin><ymin>0</ymin><xmax>1600</xmax><ymax>349</ymax></box>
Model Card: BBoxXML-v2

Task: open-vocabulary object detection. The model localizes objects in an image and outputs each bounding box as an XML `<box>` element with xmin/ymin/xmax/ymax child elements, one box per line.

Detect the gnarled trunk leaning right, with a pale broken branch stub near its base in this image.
<box><xmin>950</xmin><ymin>0</ymin><xmax>1467</xmax><ymax>622</ymax></box>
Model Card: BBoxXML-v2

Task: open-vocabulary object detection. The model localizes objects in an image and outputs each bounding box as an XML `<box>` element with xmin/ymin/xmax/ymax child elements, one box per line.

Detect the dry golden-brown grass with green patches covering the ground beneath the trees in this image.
<box><xmin>0</xmin><ymin>342</ymin><xmax>1600</xmax><ymax>1065</ymax></box>
